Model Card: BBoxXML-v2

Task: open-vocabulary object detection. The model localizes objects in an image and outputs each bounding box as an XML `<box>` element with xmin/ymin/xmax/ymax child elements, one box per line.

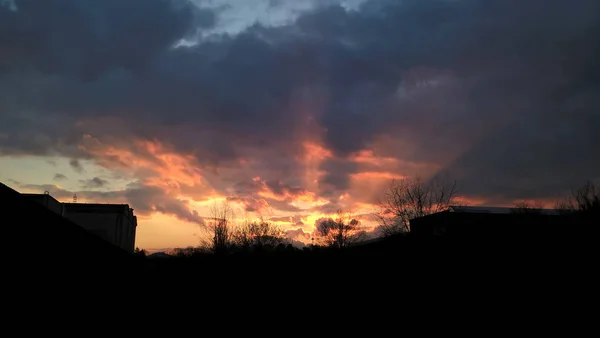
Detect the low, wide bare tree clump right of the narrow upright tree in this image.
<box><xmin>233</xmin><ymin>220</ymin><xmax>287</xmax><ymax>249</ymax></box>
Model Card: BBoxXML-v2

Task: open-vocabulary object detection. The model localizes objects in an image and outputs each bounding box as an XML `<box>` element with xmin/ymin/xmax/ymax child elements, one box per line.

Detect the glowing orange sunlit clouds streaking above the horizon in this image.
<box><xmin>70</xmin><ymin>135</ymin><xmax>428</xmax><ymax>247</ymax></box>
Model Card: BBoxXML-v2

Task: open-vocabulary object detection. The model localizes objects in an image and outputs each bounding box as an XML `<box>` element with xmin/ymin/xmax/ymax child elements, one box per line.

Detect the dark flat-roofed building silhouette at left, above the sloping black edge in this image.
<box><xmin>23</xmin><ymin>192</ymin><xmax>137</xmax><ymax>252</ymax></box>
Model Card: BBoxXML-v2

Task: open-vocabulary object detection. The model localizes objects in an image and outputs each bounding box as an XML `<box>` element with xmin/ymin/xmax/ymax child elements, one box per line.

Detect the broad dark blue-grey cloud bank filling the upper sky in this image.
<box><xmin>0</xmin><ymin>0</ymin><xmax>600</xmax><ymax>203</ymax></box>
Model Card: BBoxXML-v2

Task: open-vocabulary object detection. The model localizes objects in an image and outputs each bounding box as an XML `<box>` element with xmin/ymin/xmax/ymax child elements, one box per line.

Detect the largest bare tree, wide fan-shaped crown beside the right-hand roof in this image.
<box><xmin>376</xmin><ymin>176</ymin><xmax>457</xmax><ymax>236</ymax></box>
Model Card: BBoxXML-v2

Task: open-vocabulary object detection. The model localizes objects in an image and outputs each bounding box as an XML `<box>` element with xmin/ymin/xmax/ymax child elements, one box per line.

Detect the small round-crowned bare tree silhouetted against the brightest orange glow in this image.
<box><xmin>316</xmin><ymin>210</ymin><xmax>366</xmax><ymax>248</ymax></box>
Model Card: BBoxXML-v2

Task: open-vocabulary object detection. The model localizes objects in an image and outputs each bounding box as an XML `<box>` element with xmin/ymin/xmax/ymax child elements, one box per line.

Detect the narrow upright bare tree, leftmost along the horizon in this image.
<box><xmin>207</xmin><ymin>201</ymin><xmax>234</xmax><ymax>253</ymax></box>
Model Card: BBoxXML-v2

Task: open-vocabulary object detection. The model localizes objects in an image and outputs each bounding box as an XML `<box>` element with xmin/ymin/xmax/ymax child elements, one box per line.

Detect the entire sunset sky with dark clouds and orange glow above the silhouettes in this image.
<box><xmin>0</xmin><ymin>0</ymin><xmax>600</xmax><ymax>249</ymax></box>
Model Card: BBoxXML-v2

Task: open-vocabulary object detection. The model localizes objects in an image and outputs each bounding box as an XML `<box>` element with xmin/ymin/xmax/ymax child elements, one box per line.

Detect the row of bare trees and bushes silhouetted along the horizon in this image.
<box><xmin>136</xmin><ymin>177</ymin><xmax>600</xmax><ymax>258</ymax></box>
